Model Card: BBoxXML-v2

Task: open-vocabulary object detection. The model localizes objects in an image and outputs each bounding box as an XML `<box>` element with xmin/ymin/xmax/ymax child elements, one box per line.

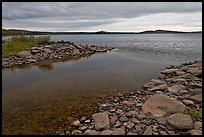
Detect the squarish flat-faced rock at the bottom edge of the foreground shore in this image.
<box><xmin>92</xmin><ymin>112</ymin><xmax>110</xmax><ymax>130</ymax></box>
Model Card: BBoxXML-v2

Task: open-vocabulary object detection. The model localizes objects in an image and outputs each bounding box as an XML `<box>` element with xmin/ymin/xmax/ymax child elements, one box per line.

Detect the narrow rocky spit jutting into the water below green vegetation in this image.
<box><xmin>2</xmin><ymin>41</ymin><xmax>114</xmax><ymax>68</ymax></box>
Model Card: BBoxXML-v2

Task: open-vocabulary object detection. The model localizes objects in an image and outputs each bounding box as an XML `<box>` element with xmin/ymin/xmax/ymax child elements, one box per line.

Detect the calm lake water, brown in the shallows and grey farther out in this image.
<box><xmin>2</xmin><ymin>34</ymin><xmax>202</xmax><ymax>134</ymax></box>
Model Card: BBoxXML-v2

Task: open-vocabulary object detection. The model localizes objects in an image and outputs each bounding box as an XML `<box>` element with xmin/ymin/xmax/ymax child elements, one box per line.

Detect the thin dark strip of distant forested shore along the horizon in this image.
<box><xmin>2</xmin><ymin>28</ymin><xmax>202</xmax><ymax>36</ymax></box>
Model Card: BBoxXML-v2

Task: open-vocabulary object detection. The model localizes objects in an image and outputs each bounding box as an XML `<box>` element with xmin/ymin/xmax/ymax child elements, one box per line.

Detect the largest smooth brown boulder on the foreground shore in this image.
<box><xmin>142</xmin><ymin>94</ymin><xmax>186</xmax><ymax>117</ymax></box>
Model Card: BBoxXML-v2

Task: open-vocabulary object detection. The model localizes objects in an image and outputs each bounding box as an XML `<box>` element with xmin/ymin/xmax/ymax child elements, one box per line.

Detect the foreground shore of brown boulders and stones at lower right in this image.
<box><xmin>57</xmin><ymin>60</ymin><xmax>202</xmax><ymax>135</ymax></box>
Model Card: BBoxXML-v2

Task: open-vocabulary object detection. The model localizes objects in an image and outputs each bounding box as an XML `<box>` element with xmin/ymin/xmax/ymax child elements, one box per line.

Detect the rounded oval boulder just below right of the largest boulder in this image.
<box><xmin>167</xmin><ymin>113</ymin><xmax>193</xmax><ymax>129</ymax></box>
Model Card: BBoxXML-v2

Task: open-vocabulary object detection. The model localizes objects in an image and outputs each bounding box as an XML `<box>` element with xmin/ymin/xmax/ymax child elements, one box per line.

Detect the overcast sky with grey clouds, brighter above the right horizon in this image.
<box><xmin>2</xmin><ymin>2</ymin><xmax>202</xmax><ymax>32</ymax></box>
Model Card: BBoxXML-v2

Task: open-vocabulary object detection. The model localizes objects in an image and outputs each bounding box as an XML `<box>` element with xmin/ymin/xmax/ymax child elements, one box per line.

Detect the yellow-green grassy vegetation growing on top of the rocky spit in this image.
<box><xmin>2</xmin><ymin>36</ymin><xmax>50</xmax><ymax>57</ymax></box>
